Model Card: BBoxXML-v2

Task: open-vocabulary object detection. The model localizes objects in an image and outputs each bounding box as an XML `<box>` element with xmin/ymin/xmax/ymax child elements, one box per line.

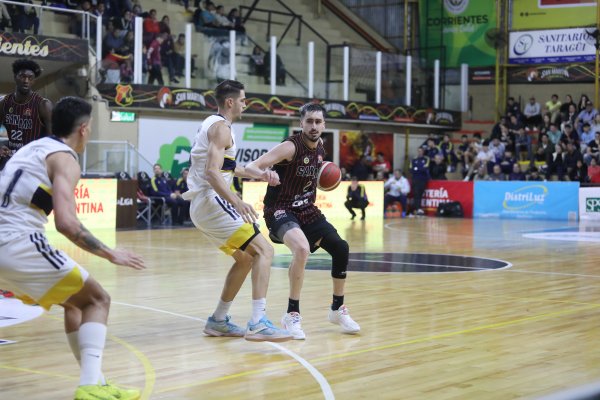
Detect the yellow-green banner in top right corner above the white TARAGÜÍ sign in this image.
<box><xmin>511</xmin><ymin>0</ymin><xmax>596</xmax><ymax>30</ymax></box>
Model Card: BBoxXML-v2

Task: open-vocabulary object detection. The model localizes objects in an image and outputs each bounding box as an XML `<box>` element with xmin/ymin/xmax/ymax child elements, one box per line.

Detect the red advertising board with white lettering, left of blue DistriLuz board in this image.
<box><xmin>421</xmin><ymin>181</ymin><xmax>473</xmax><ymax>218</ymax></box>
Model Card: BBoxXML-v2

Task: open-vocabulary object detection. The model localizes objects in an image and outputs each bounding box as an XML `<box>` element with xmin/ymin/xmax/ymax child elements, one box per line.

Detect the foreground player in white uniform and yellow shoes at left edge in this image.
<box><xmin>0</xmin><ymin>97</ymin><xmax>145</xmax><ymax>400</ymax></box>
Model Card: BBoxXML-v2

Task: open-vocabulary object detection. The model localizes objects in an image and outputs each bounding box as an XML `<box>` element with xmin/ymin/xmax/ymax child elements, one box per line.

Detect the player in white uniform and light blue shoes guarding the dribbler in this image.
<box><xmin>183</xmin><ymin>80</ymin><xmax>292</xmax><ymax>342</ymax></box>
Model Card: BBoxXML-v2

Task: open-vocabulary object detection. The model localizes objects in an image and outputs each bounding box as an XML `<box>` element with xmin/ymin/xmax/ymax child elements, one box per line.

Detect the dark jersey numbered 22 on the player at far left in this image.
<box><xmin>2</xmin><ymin>92</ymin><xmax>48</xmax><ymax>153</ymax></box>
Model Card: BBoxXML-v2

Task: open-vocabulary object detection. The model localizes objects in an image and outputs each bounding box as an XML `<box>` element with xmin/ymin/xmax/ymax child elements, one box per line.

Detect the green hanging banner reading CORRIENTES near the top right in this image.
<box><xmin>419</xmin><ymin>0</ymin><xmax>496</xmax><ymax>68</ymax></box>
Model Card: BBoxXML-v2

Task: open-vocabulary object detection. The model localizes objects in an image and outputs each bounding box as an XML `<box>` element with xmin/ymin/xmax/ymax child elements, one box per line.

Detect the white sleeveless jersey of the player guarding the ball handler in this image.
<box><xmin>183</xmin><ymin>114</ymin><xmax>236</xmax><ymax>200</ymax></box>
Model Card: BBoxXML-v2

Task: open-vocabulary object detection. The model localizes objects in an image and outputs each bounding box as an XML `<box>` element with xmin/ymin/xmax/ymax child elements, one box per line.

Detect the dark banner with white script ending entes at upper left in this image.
<box><xmin>0</xmin><ymin>32</ymin><xmax>88</xmax><ymax>64</ymax></box>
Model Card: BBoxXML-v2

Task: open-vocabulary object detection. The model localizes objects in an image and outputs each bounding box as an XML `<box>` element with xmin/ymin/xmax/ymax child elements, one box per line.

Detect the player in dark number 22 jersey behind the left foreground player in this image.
<box><xmin>0</xmin><ymin>59</ymin><xmax>52</xmax><ymax>155</ymax></box>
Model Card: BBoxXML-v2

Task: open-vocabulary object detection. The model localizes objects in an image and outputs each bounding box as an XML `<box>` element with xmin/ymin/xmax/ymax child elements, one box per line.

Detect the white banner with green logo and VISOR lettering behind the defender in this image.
<box><xmin>138</xmin><ymin>118</ymin><xmax>289</xmax><ymax>178</ymax></box>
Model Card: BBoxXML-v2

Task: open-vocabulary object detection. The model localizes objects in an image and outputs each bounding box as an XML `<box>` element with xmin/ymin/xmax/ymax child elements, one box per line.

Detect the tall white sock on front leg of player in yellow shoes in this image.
<box><xmin>77</xmin><ymin>322</ymin><xmax>106</xmax><ymax>385</ymax></box>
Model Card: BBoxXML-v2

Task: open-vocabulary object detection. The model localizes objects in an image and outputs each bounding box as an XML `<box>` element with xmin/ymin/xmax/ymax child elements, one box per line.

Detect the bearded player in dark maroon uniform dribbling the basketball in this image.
<box><xmin>250</xmin><ymin>103</ymin><xmax>360</xmax><ymax>339</ymax></box>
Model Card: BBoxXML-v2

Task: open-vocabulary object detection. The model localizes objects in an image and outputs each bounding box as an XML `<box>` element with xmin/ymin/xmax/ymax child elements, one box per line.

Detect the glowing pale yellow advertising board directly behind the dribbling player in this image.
<box><xmin>243</xmin><ymin>181</ymin><xmax>383</xmax><ymax>221</ymax></box>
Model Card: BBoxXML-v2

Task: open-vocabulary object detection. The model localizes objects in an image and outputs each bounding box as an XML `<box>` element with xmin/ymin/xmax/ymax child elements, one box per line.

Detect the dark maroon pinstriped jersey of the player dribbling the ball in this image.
<box><xmin>264</xmin><ymin>133</ymin><xmax>325</xmax><ymax>224</ymax></box>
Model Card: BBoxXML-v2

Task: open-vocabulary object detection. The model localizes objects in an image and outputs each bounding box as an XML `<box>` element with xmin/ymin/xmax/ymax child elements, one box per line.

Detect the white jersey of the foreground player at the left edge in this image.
<box><xmin>0</xmin><ymin>136</ymin><xmax>78</xmax><ymax>236</ymax></box>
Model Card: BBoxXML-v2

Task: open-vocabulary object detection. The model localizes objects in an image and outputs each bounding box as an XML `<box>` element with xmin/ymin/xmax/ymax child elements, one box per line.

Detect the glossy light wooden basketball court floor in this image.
<box><xmin>0</xmin><ymin>217</ymin><xmax>600</xmax><ymax>400</ymax></box>
